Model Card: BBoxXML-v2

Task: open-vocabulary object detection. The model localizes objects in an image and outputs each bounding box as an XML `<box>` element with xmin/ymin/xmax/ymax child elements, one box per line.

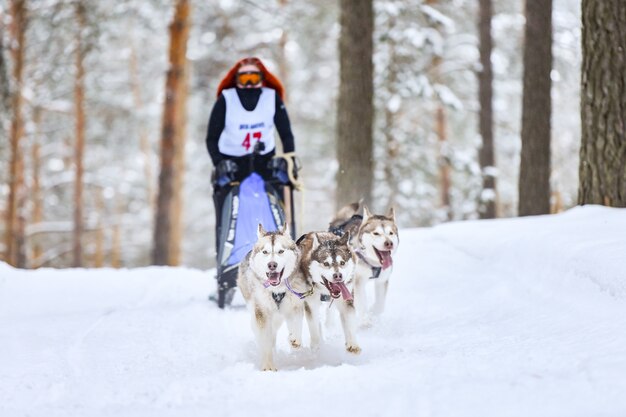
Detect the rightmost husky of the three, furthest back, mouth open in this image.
<box><xmin>329</xmin><ymin>202</ymin><xmax>399</xmax><ymax>321</ymax></box>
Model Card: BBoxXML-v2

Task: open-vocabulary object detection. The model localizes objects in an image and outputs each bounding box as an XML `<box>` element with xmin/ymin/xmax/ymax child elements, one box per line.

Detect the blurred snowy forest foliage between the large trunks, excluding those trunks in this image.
<box><xmin>0</xmin><ymin>0</ymin><xmax>582</xmax><ymax>268</ymax></box>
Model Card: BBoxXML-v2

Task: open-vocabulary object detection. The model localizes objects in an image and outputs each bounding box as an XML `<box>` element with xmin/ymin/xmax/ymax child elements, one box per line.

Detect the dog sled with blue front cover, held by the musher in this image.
<box><xmin>213</xmin><ymin>142</ymin><xmax>298</xmax><ymax>308</ymax></box>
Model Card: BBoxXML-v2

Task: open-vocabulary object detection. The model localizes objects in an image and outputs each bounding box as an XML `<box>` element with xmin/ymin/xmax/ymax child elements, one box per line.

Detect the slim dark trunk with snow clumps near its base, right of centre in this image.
<box><xmin>478</xmin><ymin>0</ymin><xmax>497</xmax><ymax>219</ymax></box>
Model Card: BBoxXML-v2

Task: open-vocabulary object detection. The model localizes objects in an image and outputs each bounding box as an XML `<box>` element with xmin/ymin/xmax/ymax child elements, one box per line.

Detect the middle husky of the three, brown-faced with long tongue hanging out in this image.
<box><xmin>298</xmin><ymin>232</ymin><xmax>361</xmax><ymax>353</ymax></box>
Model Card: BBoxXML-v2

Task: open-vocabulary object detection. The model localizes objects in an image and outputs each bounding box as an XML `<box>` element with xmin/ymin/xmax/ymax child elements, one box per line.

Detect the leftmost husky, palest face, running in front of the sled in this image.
<box><xmin>237</xmin><ymin>224</ymin><xmax>310</xmax><ymax>371</ymax></box>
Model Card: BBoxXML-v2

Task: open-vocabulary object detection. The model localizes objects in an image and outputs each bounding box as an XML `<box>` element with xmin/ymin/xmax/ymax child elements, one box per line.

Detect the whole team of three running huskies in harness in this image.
<box><xmin>237</xmin><ymin>203</ymin><xmax>399</xmax><ymax>371</ymax></box>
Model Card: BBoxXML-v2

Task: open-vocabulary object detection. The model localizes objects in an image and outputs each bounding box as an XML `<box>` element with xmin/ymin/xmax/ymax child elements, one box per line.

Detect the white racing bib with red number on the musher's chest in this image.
<box><xmin>217</xmin><ymin>87</ymin><xmax>276</xmax><ymax>156</ymax></box>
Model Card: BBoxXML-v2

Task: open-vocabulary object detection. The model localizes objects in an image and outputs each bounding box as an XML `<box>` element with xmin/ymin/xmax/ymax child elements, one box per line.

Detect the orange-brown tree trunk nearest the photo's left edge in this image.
<box><xmin>5</xmin><ymin>0</ymin><xmax>27</xmax><ymax>266</ymax></box>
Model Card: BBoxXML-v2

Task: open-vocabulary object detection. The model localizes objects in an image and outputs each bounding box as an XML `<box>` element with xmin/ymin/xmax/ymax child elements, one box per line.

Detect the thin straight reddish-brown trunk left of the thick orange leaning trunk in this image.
<box><xmin>72</xmin><ymin>1</ymin><xmax>85</xmax><ymax>267</ymax></box>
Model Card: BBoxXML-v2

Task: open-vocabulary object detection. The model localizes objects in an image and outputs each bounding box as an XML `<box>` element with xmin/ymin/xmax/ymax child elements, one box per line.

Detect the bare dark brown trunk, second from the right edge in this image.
<box><xmin>519</xmin><ymin>0</ymin><xmax>552</xmax><ymax>216</ymax></box>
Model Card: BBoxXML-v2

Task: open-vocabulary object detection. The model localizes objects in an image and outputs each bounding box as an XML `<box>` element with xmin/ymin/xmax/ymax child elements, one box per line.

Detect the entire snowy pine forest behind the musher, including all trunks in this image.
<box><xmin>0</xmin><ymin>0</ymin><xmax>626</xmax><ymax>269</ymax></box>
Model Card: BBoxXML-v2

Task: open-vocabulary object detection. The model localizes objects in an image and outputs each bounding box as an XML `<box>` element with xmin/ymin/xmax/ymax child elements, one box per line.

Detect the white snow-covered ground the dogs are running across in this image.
<box><xmin>0</xmin><ymin>206</ymin><xmax>626</xmax><ymax>417</ymax></box>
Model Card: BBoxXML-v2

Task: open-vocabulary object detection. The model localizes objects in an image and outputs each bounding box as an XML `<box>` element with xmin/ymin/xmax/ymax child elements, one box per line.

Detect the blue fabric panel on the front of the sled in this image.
<box><xmin>228</xmin><ymin>172</ymin><xmax>278</xmax><ymax>265</ymax></box>
